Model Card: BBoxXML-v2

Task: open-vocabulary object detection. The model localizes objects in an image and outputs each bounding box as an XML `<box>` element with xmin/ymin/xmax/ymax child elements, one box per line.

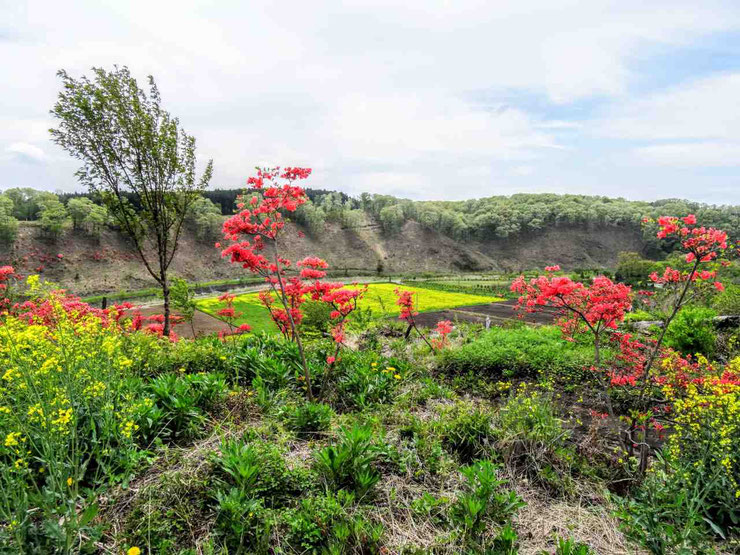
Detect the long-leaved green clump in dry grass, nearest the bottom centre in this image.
<box><xmin>316</xmin><ymin>425</ymin><xmax>381</xmax><ymax>498</ymax></box>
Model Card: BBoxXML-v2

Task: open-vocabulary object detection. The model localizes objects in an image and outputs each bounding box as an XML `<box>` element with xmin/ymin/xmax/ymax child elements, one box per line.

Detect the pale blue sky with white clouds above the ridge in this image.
<box><xmin>0</xmin><ymin>0</ymin><xmax>740</xmax><ymax>204</ymax></box>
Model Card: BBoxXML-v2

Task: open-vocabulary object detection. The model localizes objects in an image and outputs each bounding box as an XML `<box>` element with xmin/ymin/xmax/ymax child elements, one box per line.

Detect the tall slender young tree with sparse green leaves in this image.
<box><xmin>50</xmin><ymin>67</ymin><xmax>213</xmax><ymax>336</ymax></box>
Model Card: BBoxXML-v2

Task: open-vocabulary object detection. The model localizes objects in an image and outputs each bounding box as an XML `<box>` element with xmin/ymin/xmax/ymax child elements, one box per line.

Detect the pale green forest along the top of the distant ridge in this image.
<box><xmin>0</xmin><ymin>189</ymin><xmax>740</xmax><ymax>255</ymax></box>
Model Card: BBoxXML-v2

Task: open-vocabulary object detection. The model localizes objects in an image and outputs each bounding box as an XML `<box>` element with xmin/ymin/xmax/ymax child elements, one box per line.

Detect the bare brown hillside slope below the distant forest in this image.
<box><xmin>0</xmin><ymin>222</ymin><xmax>643</xmax><ymax>295</ymax></box>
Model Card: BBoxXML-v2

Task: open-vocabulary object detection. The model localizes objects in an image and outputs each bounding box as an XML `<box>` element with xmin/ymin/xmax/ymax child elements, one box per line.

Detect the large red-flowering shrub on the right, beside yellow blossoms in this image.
<box><xmin>511</xmin><ymin>215</ymin><xmax>736</xmax><ymax>471</ymax></box>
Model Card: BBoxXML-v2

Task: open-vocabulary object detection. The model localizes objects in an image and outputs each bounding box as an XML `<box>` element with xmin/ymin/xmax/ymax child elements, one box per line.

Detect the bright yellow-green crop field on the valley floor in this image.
<box><xmin>198</xmin><ymin>283</ymin><xmax>502</xmax><ymax>333</ymax></box>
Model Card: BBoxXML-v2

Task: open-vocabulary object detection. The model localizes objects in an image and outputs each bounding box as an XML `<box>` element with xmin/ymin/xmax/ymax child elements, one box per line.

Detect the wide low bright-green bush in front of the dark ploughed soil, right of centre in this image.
<box><xmin>440</xmin><ymin>326</ymin><xmax>596</xmax><ymax>382</ymax></box>
